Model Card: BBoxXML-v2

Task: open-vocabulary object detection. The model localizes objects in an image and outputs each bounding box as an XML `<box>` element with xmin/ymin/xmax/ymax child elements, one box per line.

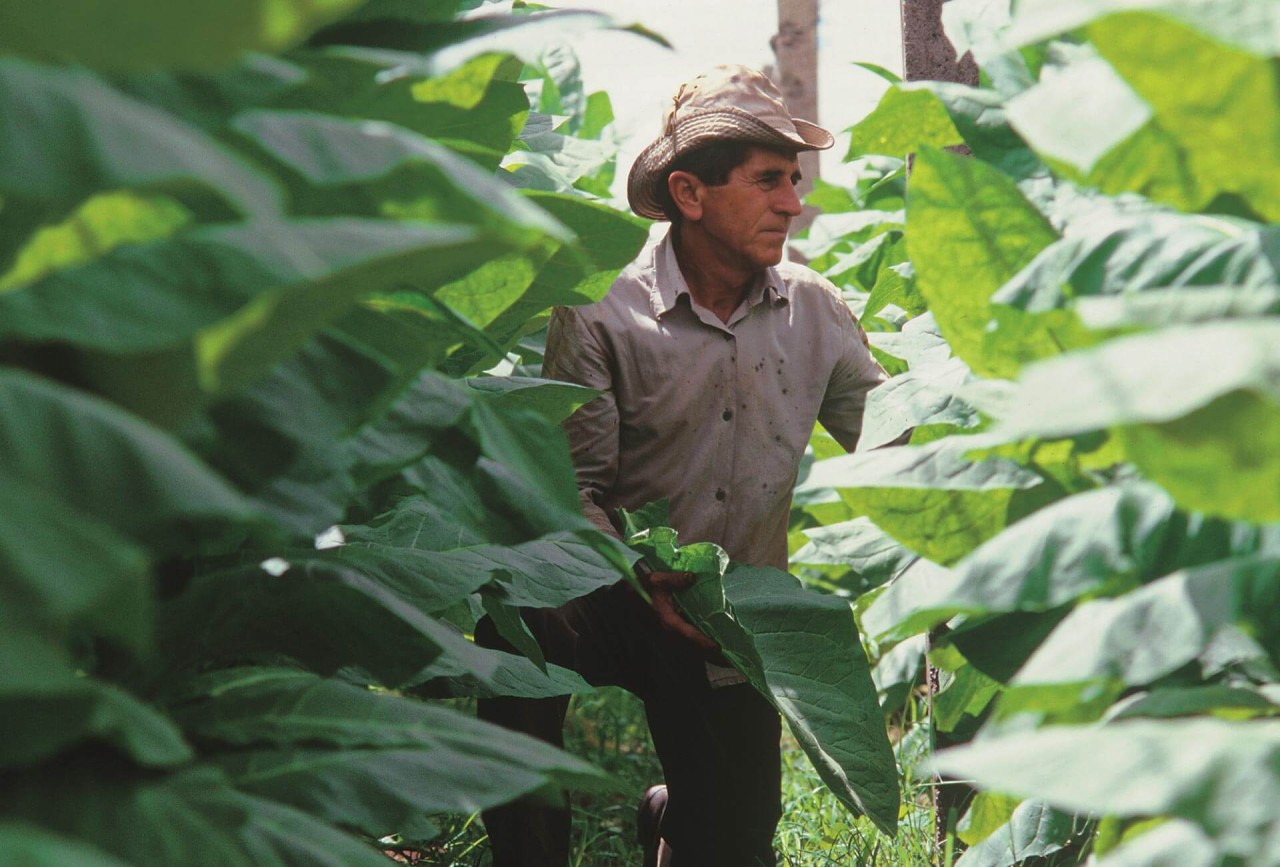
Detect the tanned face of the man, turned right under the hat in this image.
<box><xmin>700</xmin><ymin>147</ymin><xmax>800</xmax><ymax>271</ymax></box>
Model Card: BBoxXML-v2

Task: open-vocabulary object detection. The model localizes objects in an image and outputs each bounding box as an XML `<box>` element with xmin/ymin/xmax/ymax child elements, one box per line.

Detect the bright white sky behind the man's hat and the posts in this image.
<box><xmin>548</xmin><ymin>0</ymin><xmax>902</xmax><ymax>190</ymax></box>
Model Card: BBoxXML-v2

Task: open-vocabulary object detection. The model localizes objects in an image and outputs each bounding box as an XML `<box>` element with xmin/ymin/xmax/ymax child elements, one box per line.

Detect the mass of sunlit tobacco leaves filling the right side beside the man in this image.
<box><xmin>794</xmin><ymin>0</ymin><xmax>1280</xmax><ymax>867</ymax></box>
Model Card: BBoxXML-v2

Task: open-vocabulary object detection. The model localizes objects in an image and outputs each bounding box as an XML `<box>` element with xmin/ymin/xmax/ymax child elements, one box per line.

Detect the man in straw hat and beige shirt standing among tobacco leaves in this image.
<box><xmin>477</xmin><ymin>67</ymin><xmax>886</xmax><ymax>867</ymax></box>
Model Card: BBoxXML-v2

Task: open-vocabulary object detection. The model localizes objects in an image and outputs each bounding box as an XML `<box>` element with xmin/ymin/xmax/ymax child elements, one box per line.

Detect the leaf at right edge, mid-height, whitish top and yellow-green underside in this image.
<box><xmin>1000</xmin><ymin>319</ymin><xmax>1280</xmax><ymax>521</ymax></box>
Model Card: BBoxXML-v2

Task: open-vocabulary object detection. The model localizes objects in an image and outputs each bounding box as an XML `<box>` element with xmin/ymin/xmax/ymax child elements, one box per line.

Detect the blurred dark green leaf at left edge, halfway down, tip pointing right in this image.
<box><xmin>0</xmin><ymin>369</ymin><xmax>257</xmax><ymax>548</ymax></box>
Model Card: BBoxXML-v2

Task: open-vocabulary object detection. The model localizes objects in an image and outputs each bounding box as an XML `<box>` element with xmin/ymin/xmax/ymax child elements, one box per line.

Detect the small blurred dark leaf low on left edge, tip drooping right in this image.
<box><xmin>0</xmin><ymin>679</ymin><xmax>195</xmax><ymax>767</ymax></box>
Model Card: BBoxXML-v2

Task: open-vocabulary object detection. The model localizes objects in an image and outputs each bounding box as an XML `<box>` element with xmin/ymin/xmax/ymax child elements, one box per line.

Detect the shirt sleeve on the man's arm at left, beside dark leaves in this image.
<box><xmin>543</xmin><ymin>307</ymin><xmax>618</xmax><ymax>537</ymax></box>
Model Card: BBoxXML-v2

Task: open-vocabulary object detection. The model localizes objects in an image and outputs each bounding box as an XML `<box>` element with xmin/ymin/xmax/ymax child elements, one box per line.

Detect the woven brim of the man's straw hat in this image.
<box><xmin>627</xmin><ymin>108</ymin><xmax>836</xmax><ymax>220</ymax></box>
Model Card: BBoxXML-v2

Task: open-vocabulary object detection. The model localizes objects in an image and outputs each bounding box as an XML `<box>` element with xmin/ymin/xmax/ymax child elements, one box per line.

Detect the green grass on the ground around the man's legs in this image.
<box><xmin>399</xmin><ymin>688</ymin><xmax>933</xmax><ymax>867</ymax></box>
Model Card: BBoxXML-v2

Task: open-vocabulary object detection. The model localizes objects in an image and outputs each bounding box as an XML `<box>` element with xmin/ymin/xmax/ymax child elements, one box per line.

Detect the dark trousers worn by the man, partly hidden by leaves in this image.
<box><xmin>476</xmin><ymin>584</ymin><xmax>782</xmax><ymax>867</ymax></box>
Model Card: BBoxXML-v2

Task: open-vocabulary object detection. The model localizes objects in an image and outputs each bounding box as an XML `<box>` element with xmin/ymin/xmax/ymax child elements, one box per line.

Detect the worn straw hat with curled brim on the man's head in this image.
<box><xmin>627</xmin><ymin>65</ymin><xmax>836</xmax><ymax>220</ymax></box>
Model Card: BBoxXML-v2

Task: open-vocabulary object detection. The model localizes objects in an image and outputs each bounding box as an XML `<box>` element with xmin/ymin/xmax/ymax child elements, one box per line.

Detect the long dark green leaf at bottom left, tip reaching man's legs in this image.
<box><xmin>168</xmin><ymin>668</ymin><xmax>612</xmax><ymax>835</ymax></box>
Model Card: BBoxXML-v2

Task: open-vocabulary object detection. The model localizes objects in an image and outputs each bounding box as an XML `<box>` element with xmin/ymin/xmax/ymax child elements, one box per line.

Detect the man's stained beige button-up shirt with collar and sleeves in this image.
<box><xmin>543</xmin><ymin>227</ymin><xmax>887</xmax><ymax>569</ymax></box>
